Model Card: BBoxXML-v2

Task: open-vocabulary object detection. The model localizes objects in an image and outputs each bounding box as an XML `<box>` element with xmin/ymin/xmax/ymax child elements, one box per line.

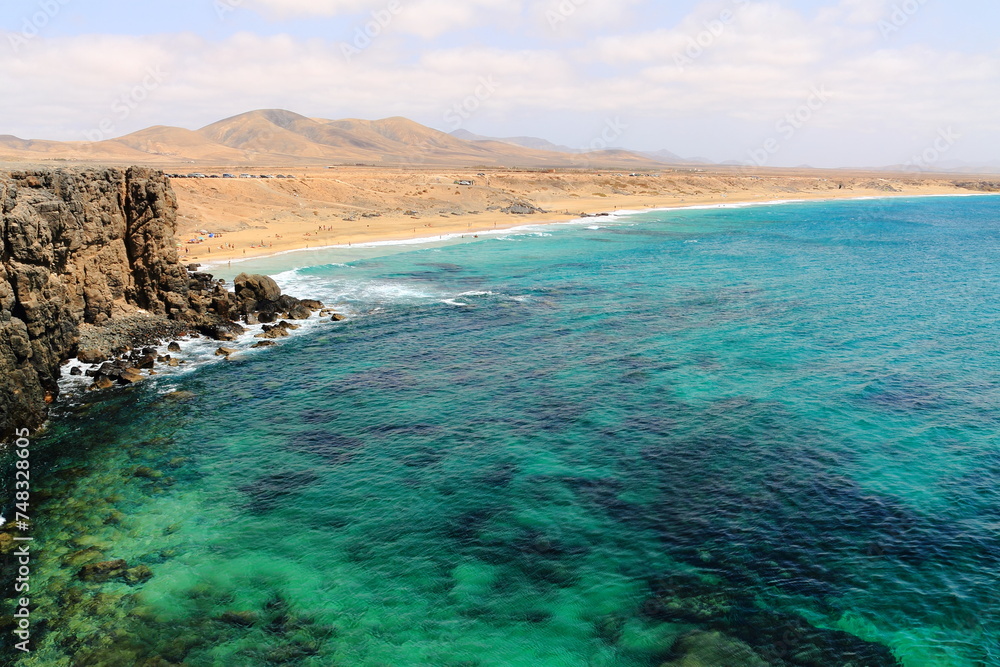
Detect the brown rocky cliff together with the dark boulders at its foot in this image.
<box><xmin>0</xmin><ymin>167</ymin><xmax>320</xmax><ymax>438</ymax></box>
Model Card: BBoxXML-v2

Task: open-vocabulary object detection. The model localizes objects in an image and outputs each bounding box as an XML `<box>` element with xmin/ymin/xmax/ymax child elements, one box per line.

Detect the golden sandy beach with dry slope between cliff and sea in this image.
<box><xmin>171</xmin><ymin>167</ymin><xmax>992</xmax><ymax>263</ymax></box>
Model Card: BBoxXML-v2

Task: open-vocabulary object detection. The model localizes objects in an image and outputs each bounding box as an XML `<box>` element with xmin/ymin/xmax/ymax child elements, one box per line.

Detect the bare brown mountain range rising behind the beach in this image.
<box><xmin>0</xmin><ymin>109</ymin><xmax>672</xmax><ymax>169</ymax></box>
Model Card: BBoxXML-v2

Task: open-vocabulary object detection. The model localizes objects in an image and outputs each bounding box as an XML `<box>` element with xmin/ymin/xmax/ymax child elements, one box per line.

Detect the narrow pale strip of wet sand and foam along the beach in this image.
<box><xmin>197</xmin><ymin>192</ymin><xmax>1000</xmax><ymax>270</ymax></box>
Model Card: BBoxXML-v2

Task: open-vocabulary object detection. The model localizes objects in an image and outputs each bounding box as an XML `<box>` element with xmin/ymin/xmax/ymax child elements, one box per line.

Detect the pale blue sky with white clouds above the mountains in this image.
<box><xmin>0</xmin><ymin>0</ymin><xmax>1000</xmax><ymax>169</ymax></box>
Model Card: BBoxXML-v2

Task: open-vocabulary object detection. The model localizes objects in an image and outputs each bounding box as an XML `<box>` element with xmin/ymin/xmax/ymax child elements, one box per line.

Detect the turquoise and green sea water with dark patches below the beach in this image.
<box><xmin>1</xmin><ymin>197</ymin><xmax>1000</xmax><ymax>667</ymax></box>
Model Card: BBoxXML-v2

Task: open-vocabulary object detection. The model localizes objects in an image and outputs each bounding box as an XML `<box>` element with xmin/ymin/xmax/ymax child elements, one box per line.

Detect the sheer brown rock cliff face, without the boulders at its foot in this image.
<box><xmin>0</xmin><ymin>168</ymin><xmax>185</xmax><ymax>436</ymax></box>
